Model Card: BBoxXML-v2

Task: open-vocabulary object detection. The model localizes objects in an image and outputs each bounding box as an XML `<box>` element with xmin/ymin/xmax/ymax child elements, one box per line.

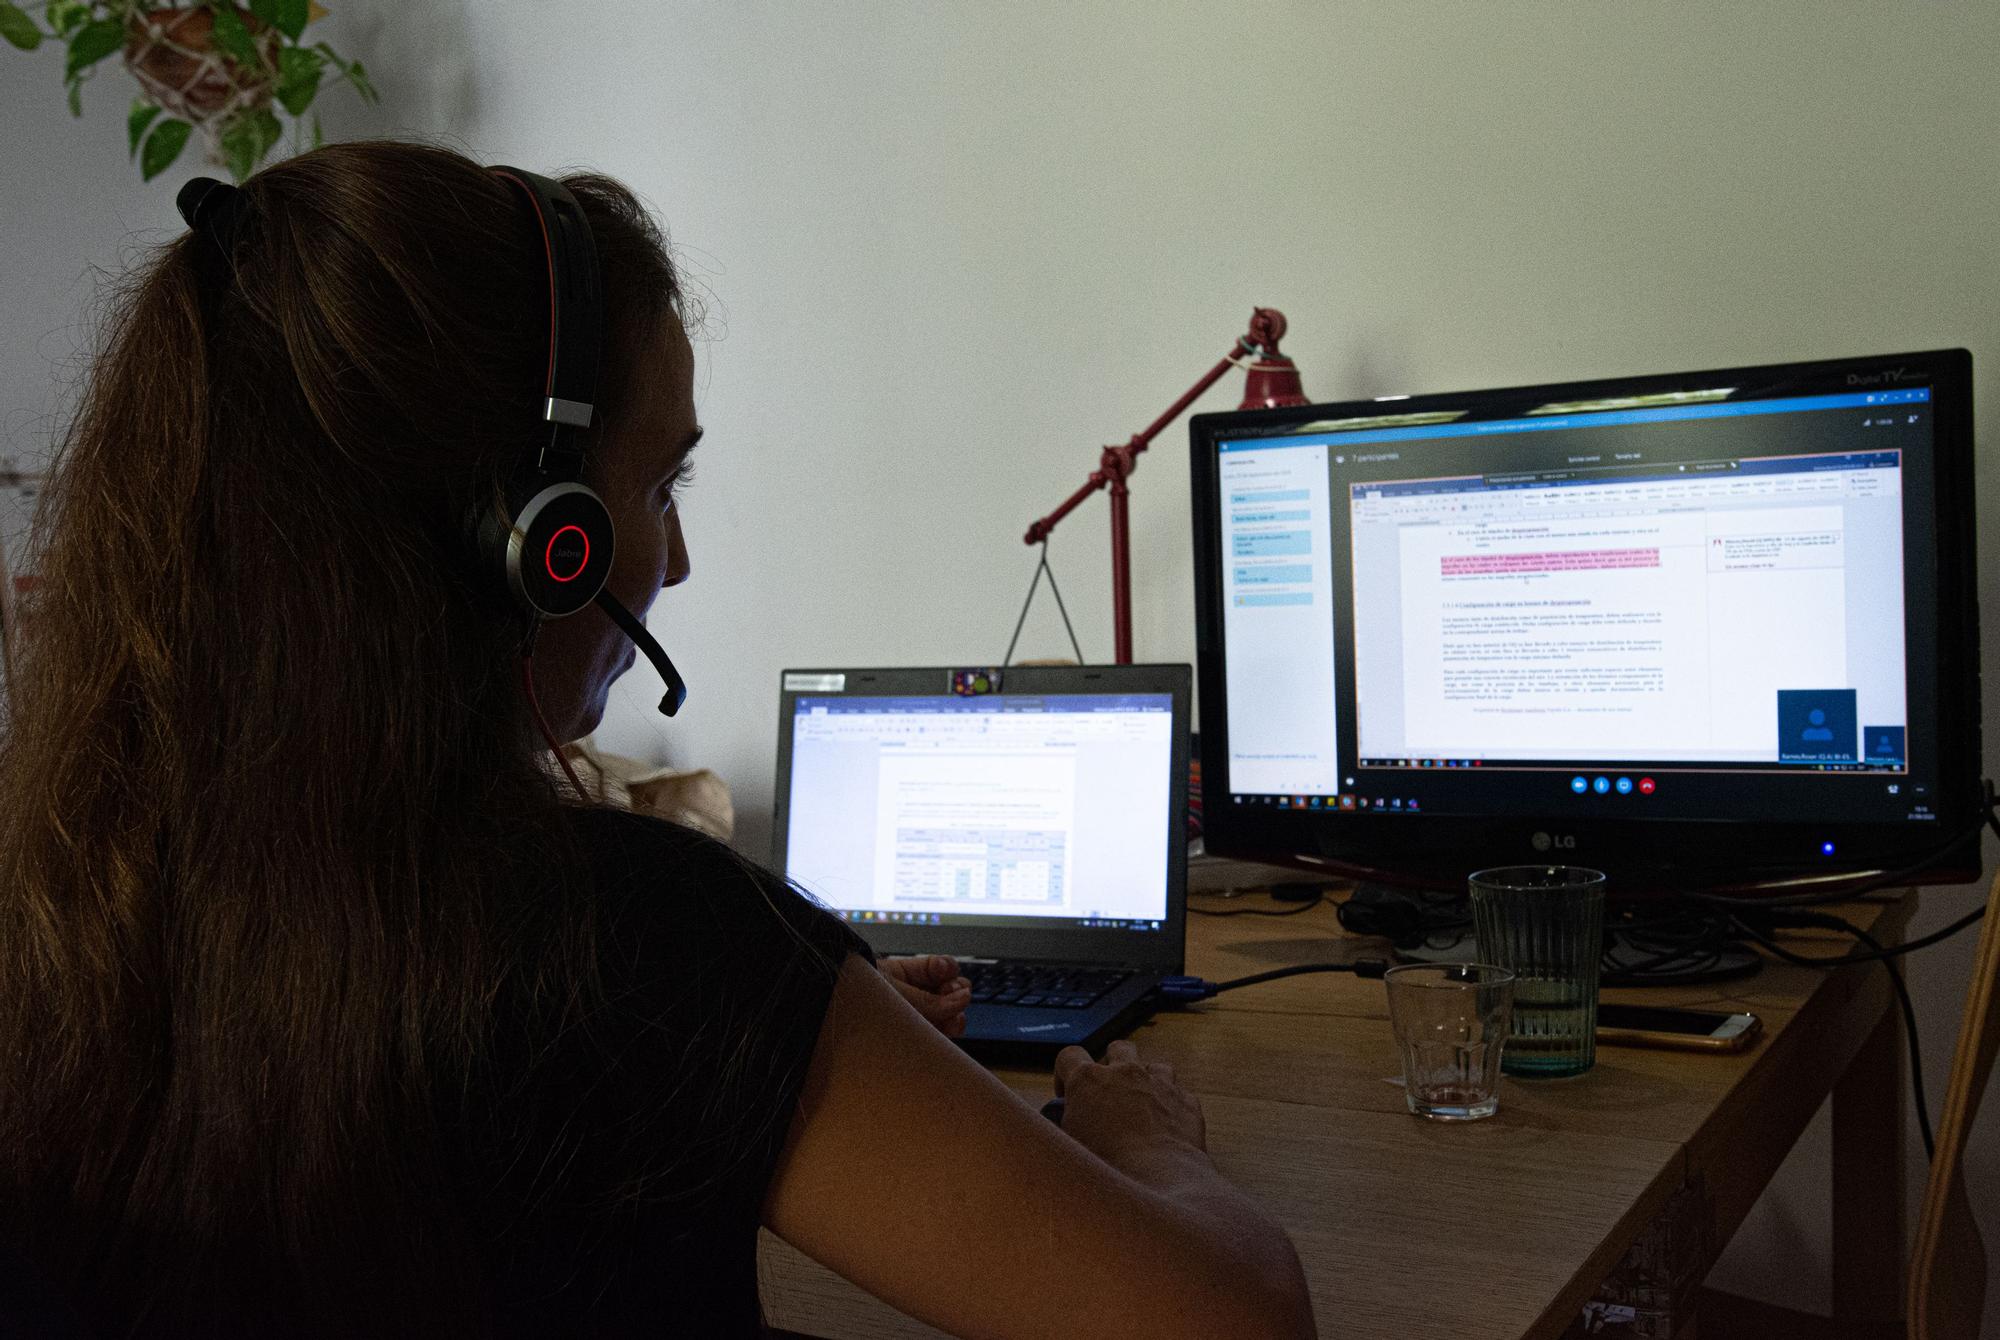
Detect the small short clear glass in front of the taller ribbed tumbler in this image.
<box><xmin>1382</xmin><ymin>964</ymin><xmax>1514</xmax><ymax>1122</ymax></box>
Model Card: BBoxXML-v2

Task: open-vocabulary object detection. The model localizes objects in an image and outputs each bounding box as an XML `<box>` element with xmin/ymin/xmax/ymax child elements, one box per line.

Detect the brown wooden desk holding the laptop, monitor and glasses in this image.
<box><xmin>760</xmin><ymin>896</ymin><xmax>1914</xmax><ymax>1340</ymax></box>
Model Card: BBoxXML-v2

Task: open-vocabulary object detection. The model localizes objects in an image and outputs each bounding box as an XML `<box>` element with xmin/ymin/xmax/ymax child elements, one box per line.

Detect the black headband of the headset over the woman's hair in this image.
<box><xmin>492</xmin><ymin>168</ymin><xmax>604</xmax><ymax>480</ymax></box>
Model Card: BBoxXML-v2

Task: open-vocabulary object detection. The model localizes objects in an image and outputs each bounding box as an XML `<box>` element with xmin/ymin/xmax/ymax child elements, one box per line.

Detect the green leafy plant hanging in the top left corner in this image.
<box><xmin>0</xmin><ymin>0</ymin><xmax>376</xmax><ymax>182</ymax></box>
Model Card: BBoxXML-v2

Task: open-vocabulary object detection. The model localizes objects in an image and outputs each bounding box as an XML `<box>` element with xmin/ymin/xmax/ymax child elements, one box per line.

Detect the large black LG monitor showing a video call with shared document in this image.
<box><xmin>1192</xmin><ymin>350</ymin><xmax>1984</xmax><ymax>892</ymax></box>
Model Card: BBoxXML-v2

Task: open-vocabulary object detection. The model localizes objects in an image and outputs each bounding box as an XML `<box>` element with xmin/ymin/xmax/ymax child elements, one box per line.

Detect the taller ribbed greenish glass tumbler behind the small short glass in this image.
<box><xmin>1470</xmin><ymin>866</ymin><xmax>1604</xmax><ymax>1076</ymax></box>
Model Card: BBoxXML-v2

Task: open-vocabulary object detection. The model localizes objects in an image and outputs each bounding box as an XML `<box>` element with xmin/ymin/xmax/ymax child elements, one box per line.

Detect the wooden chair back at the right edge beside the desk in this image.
<box><xmin>1908</xmin><ymin>876</ymin><xmax>2000</xmax><ymax>1340</ymax></box>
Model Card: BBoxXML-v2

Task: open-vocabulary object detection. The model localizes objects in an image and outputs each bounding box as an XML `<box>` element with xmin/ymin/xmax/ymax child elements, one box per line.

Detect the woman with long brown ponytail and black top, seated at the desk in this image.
<box><xmin>0</xmin><ymin>144</ymin><xmax>1312</xmax><ymax>1338</ymax></box>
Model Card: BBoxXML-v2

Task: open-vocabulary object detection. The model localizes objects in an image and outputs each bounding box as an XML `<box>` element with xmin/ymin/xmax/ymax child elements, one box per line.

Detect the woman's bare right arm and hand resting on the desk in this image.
<box><xmin>764</xmin><ymin>956</ymin><xmax>1314</xmax><ymax>1340</ymax></box>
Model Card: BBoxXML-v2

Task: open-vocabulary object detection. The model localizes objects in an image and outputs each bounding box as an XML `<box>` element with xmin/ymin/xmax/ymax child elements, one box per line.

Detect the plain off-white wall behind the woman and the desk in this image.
<box><xmin>0</xmin><ymin>0</ymin><xmax>2000</xmax><ymax>1334</ymax></box>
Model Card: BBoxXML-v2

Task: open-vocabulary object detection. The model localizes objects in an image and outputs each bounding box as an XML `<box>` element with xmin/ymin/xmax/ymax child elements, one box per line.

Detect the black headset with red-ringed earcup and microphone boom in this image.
<box><xmin>478</xmin><ymin>166</ymin><xmax>688</xmax><ymax>716</ymax></box>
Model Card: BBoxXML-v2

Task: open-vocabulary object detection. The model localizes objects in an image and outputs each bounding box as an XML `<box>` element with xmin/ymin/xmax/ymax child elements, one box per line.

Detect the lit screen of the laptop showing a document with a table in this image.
<box><xmin>784</xmin><ymin>694</ymin><xmax>1176</xmax><ymax>932</ymax></box>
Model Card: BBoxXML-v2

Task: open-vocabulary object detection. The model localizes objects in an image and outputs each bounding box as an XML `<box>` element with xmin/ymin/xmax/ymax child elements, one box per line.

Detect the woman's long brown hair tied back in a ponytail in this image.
<box><xmin>0</xmin><ymin>142</ymin><xmax>682</xmax><ymax>1334</ymax></box>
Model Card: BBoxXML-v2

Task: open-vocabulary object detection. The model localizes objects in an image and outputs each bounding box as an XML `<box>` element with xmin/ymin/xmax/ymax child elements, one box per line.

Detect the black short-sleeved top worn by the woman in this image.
<box><xmin>464</xmin><ymin>810</ymin><xmax>872</xmax><ymax>1338</ymax></box>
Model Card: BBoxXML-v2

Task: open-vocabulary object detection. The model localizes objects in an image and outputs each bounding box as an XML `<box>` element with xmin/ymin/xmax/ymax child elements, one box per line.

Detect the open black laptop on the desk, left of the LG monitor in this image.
<box><xmin>772</xmin><ymin>666</ymin><xmax>1192</xmax><ymax>1060</ymax></box>
